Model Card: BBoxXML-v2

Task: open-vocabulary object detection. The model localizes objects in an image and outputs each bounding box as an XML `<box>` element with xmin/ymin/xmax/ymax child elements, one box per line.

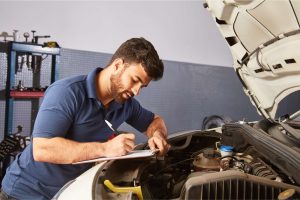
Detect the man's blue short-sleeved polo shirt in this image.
<box><xmin>2</xmin><ymin>68</ymin><xmax>154</xmax><ymax>200</ymax></box>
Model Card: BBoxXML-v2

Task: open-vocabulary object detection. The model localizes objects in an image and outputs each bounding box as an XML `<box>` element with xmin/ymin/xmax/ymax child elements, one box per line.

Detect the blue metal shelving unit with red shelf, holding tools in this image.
<box><xmin>0</xmin><ymin>40</ymin><xmax>60</xmax><ymax>180</ymax></box>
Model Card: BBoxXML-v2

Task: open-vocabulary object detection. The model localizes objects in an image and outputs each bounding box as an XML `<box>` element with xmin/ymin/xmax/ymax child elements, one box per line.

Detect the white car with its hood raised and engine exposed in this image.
<box><xmin>54</xmin><ymin>0</ymin><xmax>300</xmax><ymax>200</ymax></box>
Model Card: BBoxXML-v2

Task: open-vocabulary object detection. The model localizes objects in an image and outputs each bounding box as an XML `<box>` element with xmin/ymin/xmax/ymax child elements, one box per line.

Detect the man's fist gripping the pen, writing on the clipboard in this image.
<box><xmin>103</xmin><ymin>133</ymin><xmax>135</xmax><ymax>157</ymax></box>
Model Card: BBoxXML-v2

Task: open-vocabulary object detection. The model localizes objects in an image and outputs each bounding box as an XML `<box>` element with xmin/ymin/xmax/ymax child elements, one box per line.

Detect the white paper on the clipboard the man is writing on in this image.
<box><xmin>72</xmin><ymin>150</ymin><xmax>157</xmax><ymax>165</ymax></box>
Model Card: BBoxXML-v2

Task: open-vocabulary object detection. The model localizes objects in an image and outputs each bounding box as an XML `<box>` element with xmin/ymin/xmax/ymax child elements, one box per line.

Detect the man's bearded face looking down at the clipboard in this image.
<box><xmin>110</xmin><ymin>63</ymin><xmax>151</xmax><ymax>103</ymax></box>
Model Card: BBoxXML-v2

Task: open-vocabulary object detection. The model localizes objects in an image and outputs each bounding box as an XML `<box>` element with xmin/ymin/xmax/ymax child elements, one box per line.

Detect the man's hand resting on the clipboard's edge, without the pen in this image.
<box><xmin>148</xmin><ymin>131</ymin><xmax>170</xmax><ymax>156</ymax></box>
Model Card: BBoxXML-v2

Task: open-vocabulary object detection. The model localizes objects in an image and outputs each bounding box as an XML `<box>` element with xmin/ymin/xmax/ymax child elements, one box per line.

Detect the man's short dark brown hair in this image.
<box><xmin>109</xmin><ymin>37</ymin><xmax>164</xmax><ymax>80</ymax></box>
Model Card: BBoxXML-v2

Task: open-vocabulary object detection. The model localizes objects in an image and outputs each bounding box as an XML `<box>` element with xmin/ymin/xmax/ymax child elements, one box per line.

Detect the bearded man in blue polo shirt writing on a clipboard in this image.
<box><xmin>0</xmin><ymin>38</ymin><xmax>169</xmax><ymax>200</ymax></box>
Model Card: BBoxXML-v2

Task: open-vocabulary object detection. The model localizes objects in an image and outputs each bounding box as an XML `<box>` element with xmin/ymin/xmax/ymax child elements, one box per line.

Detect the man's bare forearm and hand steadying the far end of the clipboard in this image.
<box><xmin>146</xmin><ymin>115</ymin><xmax>170</xmax><ymax>155</ymax></box>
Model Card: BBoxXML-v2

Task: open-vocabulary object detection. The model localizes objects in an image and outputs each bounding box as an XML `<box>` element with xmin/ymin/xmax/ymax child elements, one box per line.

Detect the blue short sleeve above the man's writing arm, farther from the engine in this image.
<box><xmin>32</xmin><ymin>84</ymin><xmax>76</xmax><ymax>138</ymax></box>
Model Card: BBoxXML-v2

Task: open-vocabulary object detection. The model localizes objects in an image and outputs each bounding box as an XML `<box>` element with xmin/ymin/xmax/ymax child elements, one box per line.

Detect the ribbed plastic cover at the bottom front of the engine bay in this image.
<box><xmin>181</xmin><ymin>171</ymin><xmax>300</xmax><ymax>200</ymax></box>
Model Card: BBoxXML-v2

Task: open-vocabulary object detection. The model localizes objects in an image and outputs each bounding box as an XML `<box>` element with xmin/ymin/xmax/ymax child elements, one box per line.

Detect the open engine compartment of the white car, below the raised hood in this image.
<box><xmin>95</xmin><ymin>122</ymin><xmax>300</xmax><ymax>199</ymax></box>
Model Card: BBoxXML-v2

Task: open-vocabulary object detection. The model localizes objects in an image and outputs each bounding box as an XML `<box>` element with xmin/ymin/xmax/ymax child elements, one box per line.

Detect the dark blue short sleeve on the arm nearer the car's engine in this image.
<box><xmin>126</xmin><ymin>98</ymin><xmax>154</xmax><ymax>132</ymax></box>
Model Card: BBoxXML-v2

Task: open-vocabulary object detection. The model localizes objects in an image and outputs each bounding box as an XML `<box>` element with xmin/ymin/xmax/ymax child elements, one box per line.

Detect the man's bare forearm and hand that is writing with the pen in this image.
<box><xmin>32</xmin><ymin>134</ymin><xmax>135</xmax><ymax>164</ymax></box>
